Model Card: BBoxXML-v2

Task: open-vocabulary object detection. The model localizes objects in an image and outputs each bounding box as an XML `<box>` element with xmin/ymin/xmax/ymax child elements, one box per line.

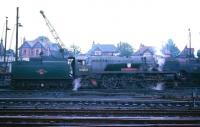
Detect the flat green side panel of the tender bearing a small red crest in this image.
<box><xmin>12</xmin><ymin>61</ymin><xmax>70</xmax><ymax>79</ymax></box>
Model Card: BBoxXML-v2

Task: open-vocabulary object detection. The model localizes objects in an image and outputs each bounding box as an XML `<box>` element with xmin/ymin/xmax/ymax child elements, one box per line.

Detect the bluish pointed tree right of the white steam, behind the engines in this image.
<box><xmin>161</xmin><ymin>39</ymin><xmax>180</xmax><ymax>57</ymax></box>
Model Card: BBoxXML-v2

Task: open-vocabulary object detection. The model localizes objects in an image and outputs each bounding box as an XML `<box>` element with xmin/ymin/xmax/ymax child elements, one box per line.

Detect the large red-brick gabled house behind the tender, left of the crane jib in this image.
<box><xmin>19</xmin><ymin>36</ymin><xmax>60</xmax><ymax>59</ymax></box>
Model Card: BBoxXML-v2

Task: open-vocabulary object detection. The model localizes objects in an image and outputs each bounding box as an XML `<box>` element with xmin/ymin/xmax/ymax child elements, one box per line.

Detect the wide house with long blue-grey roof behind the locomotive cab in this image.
<box><xmin>87</xmin><ymin>42</ymin><xmax>117</xmax><ymax>56</ymax></box>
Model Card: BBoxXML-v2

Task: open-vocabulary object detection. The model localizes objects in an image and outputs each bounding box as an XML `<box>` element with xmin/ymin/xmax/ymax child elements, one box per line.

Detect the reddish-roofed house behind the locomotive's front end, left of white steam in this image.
<box><xmin>134</xmin><ymin>44</ymin><xmax>155</xmax><ymax>57</ymax></box>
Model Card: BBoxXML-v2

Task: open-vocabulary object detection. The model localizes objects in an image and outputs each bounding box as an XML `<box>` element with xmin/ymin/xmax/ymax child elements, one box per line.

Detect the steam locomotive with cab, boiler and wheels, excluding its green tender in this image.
<box><xmin>76</xmin><ymin>56</ymin><xmax>176</xmax><ymax>89</ymax></box>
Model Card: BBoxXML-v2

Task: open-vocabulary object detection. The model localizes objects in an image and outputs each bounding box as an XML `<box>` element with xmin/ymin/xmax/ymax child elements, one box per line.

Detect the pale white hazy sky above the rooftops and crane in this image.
<box><xmin>0</xmin><ymin>0</ymin><xmax>200</xmax><ymax>52</ymax></box>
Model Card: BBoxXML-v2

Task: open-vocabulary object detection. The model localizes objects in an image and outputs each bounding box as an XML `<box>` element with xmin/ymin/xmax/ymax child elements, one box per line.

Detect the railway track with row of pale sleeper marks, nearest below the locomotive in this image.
<box><xmin>0</xmin><ymin>98</ymin><xmax>200</xmax><ymax>109</ymax></box>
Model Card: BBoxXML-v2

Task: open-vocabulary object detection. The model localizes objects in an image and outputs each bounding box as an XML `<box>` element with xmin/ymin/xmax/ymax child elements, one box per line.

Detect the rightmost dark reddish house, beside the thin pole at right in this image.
<box><xmin>178</xmin><ymin>46</ymin><xmax>194</xmax><ymax>58</ymax></box>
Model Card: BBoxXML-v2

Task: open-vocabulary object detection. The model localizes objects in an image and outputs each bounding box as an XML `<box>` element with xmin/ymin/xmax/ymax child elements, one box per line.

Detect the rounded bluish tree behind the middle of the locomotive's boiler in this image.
<box><xmin>117</xmin><ymin>42</ymin><xmax>133</xmax><ymax>57</ymax></box>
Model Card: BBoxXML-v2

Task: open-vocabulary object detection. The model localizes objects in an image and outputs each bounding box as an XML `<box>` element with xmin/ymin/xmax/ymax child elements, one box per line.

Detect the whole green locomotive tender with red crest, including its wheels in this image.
<box><xmin>11</xmin><ymin>58</ymin><xmax>73</xmax><ymax>88</ymax></box>
